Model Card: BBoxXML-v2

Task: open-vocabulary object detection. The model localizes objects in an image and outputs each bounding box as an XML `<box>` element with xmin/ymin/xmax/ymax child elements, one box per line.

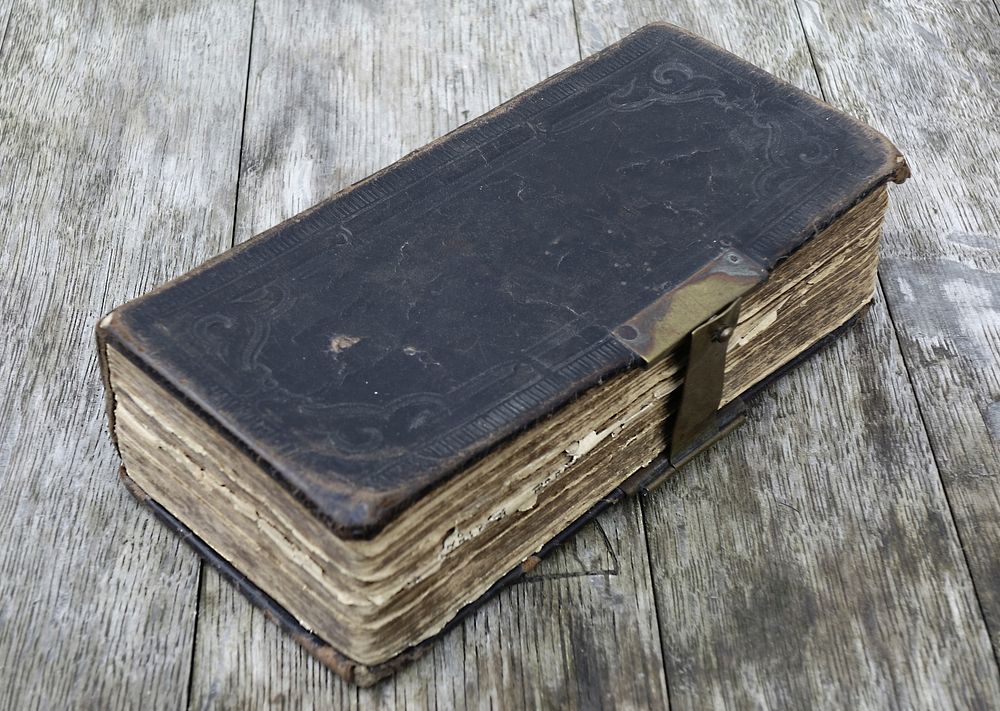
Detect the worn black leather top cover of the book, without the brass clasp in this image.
<box><xmin>99</xmin><ymin>25</ymin><xmax>906</xmax><ymax>537</ymax></box>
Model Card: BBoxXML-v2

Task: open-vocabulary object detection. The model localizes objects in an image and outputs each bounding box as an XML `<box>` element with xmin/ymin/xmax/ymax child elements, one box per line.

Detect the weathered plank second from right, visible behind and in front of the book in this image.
<box><xmin>577</xmin><ymin>0</ymin><xmax>1000</xmax><ymax>708</ymax></box>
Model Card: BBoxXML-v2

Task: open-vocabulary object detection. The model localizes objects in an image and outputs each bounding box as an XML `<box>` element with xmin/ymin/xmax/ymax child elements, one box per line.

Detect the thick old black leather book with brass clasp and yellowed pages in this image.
<box><xmin>98</xmin><ymin>25</ymin><xmax>907</xmax><ymax>683</ymax></box>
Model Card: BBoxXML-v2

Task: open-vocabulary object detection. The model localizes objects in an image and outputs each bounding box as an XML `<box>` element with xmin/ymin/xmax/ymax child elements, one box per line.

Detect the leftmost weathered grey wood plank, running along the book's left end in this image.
<box><xmin>0</xmin><ymin>2</ymin><xmax>250</xmax><ymax>709</ymax></box>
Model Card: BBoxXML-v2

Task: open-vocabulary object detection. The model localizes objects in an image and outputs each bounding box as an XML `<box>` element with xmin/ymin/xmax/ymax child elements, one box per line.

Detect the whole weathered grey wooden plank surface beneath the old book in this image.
<box><xmin>0</xmin><ymin>0</ymin><xmax>1000</xmax><ymax>709</ymax></box>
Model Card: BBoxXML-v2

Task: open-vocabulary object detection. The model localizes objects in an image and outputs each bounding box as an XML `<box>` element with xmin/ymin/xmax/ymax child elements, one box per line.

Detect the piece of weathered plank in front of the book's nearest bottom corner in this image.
<box><xmin>191</xmin><ymin>502</ymin><xmax>667</xmax><ymax>709</ymax></box>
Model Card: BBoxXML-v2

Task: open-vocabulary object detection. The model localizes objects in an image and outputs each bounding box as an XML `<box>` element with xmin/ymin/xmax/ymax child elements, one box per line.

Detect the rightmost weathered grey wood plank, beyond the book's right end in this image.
<box><xmin>799</xmin><ymin>0</ymin><xmax>1000</xmax><ymax>664</ymax></box>
